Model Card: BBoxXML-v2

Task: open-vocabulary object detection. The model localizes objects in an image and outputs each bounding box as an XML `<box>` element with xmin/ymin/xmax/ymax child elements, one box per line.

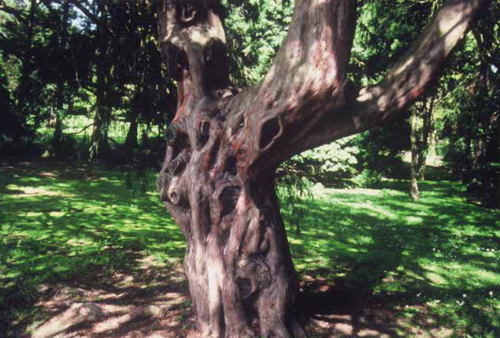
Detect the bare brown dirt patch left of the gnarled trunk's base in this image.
<box><xmin>29</xmin><ymin>257</ymin><xmax>194</xmax><ymax>338</ymax></box>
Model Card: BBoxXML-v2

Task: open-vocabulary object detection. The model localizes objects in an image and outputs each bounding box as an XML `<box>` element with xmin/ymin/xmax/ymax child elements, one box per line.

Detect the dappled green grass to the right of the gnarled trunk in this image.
<box><xmin>285</xmin><ymin>181</ymin><xmax>500</xmax><ymax>337</ymax></box>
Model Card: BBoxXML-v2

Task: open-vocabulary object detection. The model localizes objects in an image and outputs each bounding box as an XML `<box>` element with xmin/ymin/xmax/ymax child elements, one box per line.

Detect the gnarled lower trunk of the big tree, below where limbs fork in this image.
<box><xmin>159</xmin><ymin>162</ymin><xmax>300</xmax><ymax>338</ymax></box>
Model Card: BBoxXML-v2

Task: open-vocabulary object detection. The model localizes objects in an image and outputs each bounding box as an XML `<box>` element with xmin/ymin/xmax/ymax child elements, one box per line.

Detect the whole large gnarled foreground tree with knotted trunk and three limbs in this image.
<box><xmin>157</xmin><ymin>0</ymin><xmax>488</xmax><ymax>338</ymax></box>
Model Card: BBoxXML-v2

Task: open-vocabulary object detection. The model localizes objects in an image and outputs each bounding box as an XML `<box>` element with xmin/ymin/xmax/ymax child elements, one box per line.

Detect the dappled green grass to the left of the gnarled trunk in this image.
<box><xmin>0</xmin><ymin>160</ymin><xmax>188</xmax><ymax>337</ymax></box>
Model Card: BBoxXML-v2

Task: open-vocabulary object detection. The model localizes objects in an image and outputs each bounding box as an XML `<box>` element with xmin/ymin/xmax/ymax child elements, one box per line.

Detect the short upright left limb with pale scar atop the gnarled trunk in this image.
<box><xmin>158</xmin><ymin>0</ymin><xmax>230</xmax><ymax>98</ymax></box>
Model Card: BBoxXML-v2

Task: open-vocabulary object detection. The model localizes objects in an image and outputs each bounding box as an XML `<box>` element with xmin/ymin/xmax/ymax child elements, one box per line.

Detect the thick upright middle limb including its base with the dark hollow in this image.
<box><xmin>225</xmin><ymin>0</ymin><xmax>356</xmax><ymax>170</ymax></box>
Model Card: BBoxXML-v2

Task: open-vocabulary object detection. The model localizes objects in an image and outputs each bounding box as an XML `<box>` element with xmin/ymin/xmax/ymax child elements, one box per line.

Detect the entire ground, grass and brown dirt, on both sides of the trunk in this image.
<box><xmin>0</xmin><ymin>161</ymin><xmax>500</xmax><ymax>338</ymax></box>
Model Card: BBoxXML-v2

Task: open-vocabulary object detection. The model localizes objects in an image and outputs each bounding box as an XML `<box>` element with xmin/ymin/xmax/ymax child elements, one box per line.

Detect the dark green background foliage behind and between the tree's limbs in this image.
<box><xmin>0</xmin><ymin>0</ymin><xmax>499</xmax><ymax>204</ymax></box>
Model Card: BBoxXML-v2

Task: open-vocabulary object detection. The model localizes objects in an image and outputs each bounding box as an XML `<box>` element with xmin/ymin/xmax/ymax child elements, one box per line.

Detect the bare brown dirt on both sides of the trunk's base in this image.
<box><xmin>29</xmin><ymin>272</ymin><xmax>452</xmax><ymax>338</ymax></box>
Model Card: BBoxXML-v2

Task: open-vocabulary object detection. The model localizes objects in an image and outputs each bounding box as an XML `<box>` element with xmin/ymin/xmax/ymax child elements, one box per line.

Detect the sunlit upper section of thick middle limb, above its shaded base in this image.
<box><xmin>259</xmin><ymin>0</ymin><xmax>356</xmax><ymax>108</ymax></box>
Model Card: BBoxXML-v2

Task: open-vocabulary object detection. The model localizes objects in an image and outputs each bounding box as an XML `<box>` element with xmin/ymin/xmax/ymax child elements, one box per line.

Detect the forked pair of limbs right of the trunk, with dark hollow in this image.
<box><xmin>233</xmin><ymin>0</ymin><xmax>488</xmax><ymax>170</ymax></box>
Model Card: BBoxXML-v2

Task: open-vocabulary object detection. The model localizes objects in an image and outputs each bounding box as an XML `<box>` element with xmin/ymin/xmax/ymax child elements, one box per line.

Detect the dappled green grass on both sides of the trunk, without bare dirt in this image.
<box><xmin>0</xmin><ymin>162</ymin><xmax>500</xmax><ymax>337</ymax></box>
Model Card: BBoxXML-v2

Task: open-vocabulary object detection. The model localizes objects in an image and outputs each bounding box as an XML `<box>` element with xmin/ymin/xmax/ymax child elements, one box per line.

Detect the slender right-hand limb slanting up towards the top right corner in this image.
<box><xmin>350</xmin><ymin>0</ymin><xmax>488</xmax><ymax>133</ymax></box>
